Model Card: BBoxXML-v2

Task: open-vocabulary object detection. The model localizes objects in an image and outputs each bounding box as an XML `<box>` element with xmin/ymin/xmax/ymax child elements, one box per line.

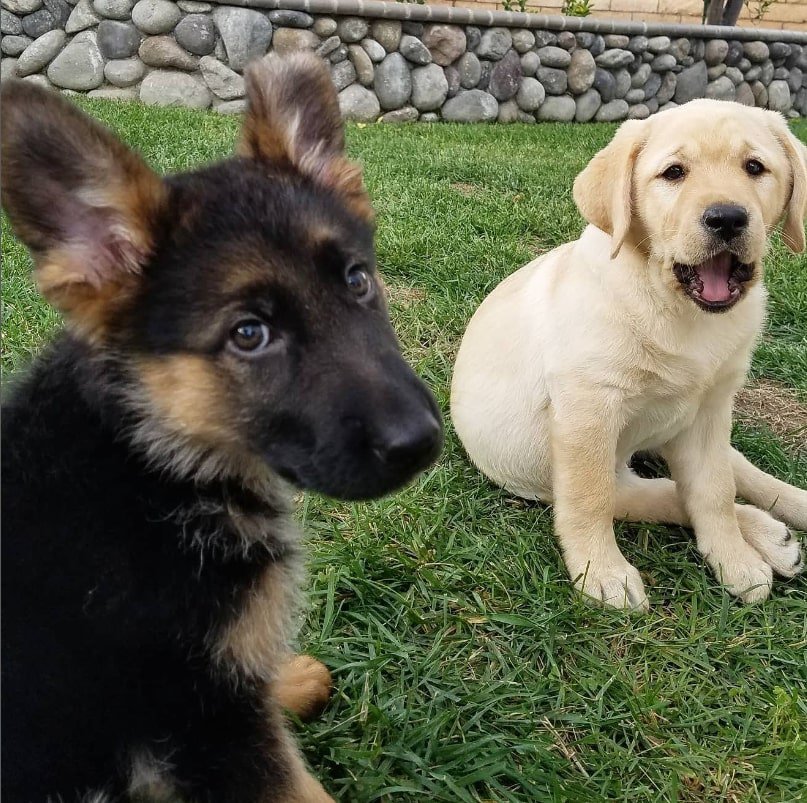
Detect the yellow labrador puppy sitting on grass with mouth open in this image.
<box><xmin>451</xmin><ymin>100</ymin><xmax>807</xmax><ymax>608</ymax></box>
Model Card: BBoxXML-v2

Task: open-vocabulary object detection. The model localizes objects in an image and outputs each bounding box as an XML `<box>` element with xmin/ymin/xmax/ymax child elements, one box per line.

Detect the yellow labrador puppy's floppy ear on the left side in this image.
<box><xmin>574</xmin><ymin>120</ymin><xmax>644</xmax><ymax>259</ymax></box>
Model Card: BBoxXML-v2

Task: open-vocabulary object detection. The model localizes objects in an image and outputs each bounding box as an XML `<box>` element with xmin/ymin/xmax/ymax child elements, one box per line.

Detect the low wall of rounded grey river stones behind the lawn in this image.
<box><xmin>1</xmin><ymin>0</ymin><xmax>807</xmax><ymax>122</ymax></box>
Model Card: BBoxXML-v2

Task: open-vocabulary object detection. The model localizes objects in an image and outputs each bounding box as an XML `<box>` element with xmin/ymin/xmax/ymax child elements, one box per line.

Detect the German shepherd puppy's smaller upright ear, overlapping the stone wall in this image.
<box><xmin>237</xmin><ymin>53</ymin><xmax>373</xmax><ymax>221</ymax></box>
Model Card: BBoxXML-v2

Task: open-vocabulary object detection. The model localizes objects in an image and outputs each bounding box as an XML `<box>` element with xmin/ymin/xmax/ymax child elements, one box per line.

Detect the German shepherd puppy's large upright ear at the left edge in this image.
<box><xmin>0</xmin><ymin>81</ymin><xmax>165</xmax><ymax>329</ymax></box>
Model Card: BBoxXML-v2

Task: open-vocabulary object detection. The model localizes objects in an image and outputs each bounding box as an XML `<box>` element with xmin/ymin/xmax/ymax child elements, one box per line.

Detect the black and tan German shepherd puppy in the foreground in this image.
<box><xmin>2</xmin><ymin>55</ymin><xmax>442</xmax><ymax>803</ymax></box>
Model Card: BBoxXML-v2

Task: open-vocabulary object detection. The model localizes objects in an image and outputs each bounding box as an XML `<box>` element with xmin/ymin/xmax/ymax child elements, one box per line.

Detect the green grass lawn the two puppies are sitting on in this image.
<box><xmin>3</xmin><ymin>102</ymin><xmax>807</xmax><ymax>803</ymax></box>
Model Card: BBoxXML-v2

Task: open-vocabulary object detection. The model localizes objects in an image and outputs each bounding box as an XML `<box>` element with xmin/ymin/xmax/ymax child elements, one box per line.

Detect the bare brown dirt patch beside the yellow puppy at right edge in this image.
<box><xmin>734</xmin><ymin>379</ymin><xmax>807</xmax><ymax>447</ymax></box>
